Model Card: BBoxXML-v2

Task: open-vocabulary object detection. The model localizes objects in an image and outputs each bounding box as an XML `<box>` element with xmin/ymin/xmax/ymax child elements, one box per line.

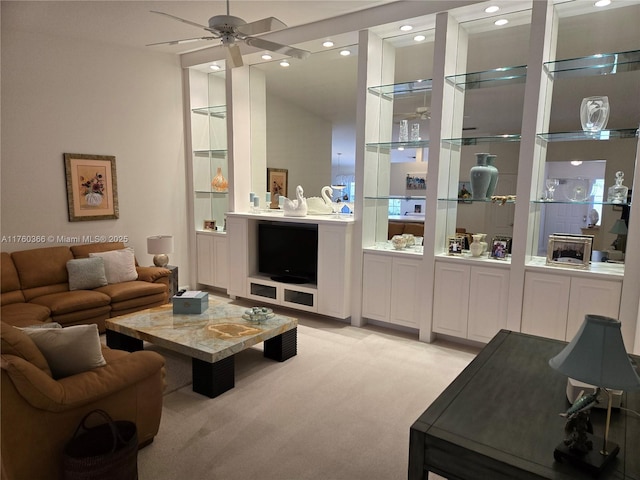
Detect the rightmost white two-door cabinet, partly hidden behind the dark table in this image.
<box><xmin>522</xmin><ymin>271</ymin><xmax>622</xmax><ymax>341</ymax></box>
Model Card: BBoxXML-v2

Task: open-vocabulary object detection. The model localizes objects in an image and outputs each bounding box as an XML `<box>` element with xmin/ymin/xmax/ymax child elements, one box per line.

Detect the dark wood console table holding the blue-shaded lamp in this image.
<box><xmin>409</xmin><ymin>330</ymin><xmax>640</xmax><ymax>480</ymax></box>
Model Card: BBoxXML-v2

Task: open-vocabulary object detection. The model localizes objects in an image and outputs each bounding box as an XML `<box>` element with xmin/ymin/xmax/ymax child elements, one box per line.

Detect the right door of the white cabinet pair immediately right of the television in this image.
<box><xmin>389</xmin><ymin>258</ymin><xmax>421</xmax><ymax>328</ymax></box>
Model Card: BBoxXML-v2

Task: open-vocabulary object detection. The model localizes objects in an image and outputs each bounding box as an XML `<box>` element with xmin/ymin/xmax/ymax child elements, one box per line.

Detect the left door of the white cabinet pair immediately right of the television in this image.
<box><xmin>362</xmin><ymin>253</ymin><xmax>392</xmax><ymax>322</ymax></box>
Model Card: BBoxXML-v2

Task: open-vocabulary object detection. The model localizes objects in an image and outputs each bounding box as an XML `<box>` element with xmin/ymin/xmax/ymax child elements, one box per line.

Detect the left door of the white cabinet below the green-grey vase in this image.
<box><xmin>433</xmin><ymin>262</ymin><xmax>471</xmax><ymax>338</ymax></box>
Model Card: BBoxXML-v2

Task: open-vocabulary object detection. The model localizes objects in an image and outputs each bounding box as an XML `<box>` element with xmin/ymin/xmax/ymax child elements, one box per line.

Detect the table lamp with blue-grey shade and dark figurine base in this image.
<box><xmin>549</xmin><ymin>315</ymin><xmax>640</xmax><ymax>473</ymax></box>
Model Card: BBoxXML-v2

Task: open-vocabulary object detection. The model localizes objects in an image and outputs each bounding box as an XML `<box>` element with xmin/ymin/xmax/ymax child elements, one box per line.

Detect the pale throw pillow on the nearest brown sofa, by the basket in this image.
<box><xmin>22</xmin><ymin>325</ymin><xmax>107</xmax><ymax>378</ymax></box>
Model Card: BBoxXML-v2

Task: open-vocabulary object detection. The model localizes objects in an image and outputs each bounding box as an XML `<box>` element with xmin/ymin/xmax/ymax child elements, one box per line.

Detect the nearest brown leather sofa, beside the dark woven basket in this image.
<box><xmin>0</xmin><ymin>322</ymin><xmax>165</xmax><ymax>480</ymax></box>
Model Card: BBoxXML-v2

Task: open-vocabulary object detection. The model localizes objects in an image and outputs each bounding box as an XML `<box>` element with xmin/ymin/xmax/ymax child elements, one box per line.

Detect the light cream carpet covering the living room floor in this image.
<box><xmin>138</xmin><ymin>297</ymin><xmax>477</xmax><ymax>480</ymax></box>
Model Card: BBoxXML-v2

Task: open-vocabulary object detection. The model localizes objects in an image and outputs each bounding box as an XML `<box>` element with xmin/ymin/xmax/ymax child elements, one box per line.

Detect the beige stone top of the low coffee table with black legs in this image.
<box><xmin>106</xmin><ymin>297</ymin><xmax>298</xmax><ymax>363</ymax></box>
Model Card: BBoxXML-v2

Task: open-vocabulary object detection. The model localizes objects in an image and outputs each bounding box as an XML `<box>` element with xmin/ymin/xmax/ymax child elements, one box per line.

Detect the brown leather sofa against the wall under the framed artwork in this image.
<box><xmin>0</xmin><ymin>242</ymin><xmax>171</xmax><ymax>332</ymax></box>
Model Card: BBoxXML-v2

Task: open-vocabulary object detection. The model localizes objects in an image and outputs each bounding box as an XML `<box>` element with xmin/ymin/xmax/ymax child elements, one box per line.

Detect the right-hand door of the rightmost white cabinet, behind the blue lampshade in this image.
<box><xmin>565</xmin><ymin>278</ymin><xmax>622</xmax><ymax>341</ymax></box>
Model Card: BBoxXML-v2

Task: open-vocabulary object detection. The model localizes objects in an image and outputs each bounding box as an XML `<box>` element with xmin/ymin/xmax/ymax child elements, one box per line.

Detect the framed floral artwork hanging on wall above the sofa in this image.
<box><xmin>64</xmin><ymin>153</ymin><xmax>119</xmax><ymax>222</ymax></box>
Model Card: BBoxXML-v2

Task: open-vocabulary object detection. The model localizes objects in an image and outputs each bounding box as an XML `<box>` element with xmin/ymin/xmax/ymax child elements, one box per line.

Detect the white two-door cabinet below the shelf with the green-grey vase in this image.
<box><xmin>433</xmin><ymin>261</ymin><xmax>509</xmax><ymax>343</ymax></box>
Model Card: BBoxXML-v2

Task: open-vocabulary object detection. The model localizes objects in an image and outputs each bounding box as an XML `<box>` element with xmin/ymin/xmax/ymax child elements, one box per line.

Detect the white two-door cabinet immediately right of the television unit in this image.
<box><xmin>362</xmin><ymin>252</ymin><xmax>422</xmax><ymax>328</ymax></box>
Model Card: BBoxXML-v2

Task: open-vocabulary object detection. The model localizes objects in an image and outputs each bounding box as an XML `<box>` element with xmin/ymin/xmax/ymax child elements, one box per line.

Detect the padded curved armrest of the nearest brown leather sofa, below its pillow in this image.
<box><xmin>0</xmin><ymin>351</ymin><xmax>165</xmax><ymax>412</ymax></box>
